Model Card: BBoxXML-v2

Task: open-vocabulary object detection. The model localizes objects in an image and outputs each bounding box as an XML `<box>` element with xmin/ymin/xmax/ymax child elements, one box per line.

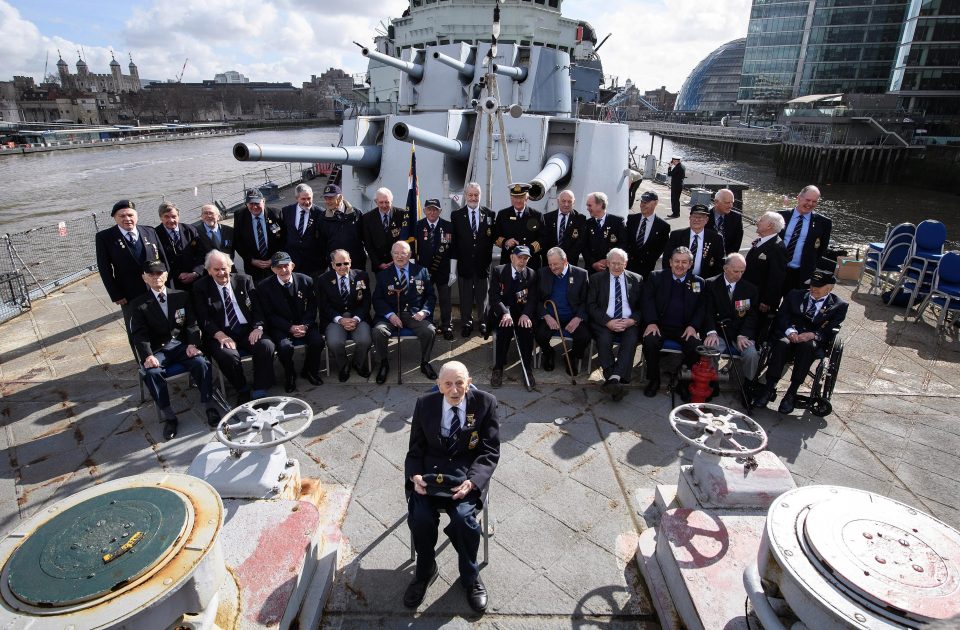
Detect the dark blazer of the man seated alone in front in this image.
<box><xmin>403</xmin><ymin>389</ymin><xmax>500</xmax><ymax>494</ymax></box>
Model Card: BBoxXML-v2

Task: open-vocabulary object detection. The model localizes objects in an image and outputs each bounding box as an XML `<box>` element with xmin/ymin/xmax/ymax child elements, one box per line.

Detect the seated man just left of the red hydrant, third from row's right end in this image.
<box><xmin>642</xmin><ymin>245</ymin><xmax>707</xmax><ymax>400</ymax></box>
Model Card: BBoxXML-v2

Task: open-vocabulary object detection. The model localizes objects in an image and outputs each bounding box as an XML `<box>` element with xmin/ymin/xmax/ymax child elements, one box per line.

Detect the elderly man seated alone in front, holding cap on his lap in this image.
<box><xmin>403</xmin><ymin>361</ymin><xmax>500</xmax><ymax>613</ymax></box>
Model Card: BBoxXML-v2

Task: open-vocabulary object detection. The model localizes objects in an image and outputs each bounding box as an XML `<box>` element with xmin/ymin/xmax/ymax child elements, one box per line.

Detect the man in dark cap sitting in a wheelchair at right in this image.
<box><xmin>753</xmin><ymin>270</ymin><xmax>848</xmax><ymax>413</ymax></box>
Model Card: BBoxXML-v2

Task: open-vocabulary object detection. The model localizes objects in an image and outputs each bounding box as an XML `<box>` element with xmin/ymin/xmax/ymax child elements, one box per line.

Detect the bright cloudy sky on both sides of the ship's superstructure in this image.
<box><xmin>0</xmin><ymin>0</ymin><xmax>750</xmax><ymax>91</ymax></box>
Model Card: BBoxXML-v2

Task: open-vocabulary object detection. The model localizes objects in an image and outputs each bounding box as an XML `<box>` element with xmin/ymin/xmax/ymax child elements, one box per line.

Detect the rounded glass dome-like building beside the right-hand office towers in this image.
<box><xmin>674</xmin><ymin>38</ymin><xmax>747</xmax><ymax>114</ymax></box>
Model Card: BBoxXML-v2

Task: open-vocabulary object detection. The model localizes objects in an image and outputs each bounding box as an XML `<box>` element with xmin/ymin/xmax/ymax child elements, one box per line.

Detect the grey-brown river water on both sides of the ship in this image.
<box><xmin>0</xmin><ymin>127</ymin><xmax>960</xmax><ymax>247</ymax></box>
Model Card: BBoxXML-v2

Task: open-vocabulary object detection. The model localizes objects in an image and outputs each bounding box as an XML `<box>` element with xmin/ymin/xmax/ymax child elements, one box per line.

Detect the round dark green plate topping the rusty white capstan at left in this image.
<box><xmin>8</xmin><ymin>487</ymin><xmax>191</xmax><ymax>606</ymax></box>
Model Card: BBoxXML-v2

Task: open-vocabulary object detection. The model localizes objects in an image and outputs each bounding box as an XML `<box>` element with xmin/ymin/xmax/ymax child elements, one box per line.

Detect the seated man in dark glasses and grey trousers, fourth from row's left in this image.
<box><xmin>317</xmin><ymin>249</ymin><xmax>373</xmax><ymax>383</ymax></box>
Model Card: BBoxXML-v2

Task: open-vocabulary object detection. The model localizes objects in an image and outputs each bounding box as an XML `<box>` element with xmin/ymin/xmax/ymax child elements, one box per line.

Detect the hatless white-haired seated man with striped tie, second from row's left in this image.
<box><xmin>193</xmin><ymin>249</ymin><xmax>274</xmax><ymax>405</ymax></box>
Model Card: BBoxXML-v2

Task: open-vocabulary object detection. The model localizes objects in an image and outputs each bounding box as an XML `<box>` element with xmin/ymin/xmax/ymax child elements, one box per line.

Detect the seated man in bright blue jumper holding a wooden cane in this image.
<box><xmin>533</xmin><ymin>247</ymin><xmax>590</xmax><ymax>376</ymax></box>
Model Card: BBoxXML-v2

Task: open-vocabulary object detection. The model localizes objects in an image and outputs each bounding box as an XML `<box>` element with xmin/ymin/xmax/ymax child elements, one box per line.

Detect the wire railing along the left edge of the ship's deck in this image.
<box><xmin>0</xmin><ymin>164</ymin><xmax>307</xmax><ymax>322</ymax></box>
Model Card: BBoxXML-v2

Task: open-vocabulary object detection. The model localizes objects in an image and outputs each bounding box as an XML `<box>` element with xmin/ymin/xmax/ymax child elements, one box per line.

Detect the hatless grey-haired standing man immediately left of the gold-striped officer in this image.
<box><xmin>450</xmin><ymin>182</ymin><xmax>496</xmax><ymax>337</ymax></box>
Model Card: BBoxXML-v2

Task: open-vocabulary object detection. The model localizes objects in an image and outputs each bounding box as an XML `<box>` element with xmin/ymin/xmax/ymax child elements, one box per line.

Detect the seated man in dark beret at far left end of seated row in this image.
<box><xmin>130</xmin><ymin>260</ymin><xmax>220</xmax><ymax>440</ymax></box>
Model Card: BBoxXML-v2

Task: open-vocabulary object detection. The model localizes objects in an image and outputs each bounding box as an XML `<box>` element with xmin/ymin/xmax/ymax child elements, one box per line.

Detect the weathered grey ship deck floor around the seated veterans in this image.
<box><xmin>0</xmin><ymin>182</ymin><xmax>960</xmax><ymax>628</ymax></box>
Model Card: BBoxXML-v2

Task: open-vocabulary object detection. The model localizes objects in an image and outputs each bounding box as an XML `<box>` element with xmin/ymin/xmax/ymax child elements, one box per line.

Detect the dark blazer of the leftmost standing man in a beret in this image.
<box><xmin>95</xmin><ymin>225</ymin><xmax>167</xmax><ymax>302</ymax></box>
